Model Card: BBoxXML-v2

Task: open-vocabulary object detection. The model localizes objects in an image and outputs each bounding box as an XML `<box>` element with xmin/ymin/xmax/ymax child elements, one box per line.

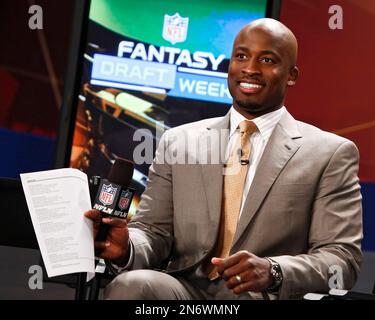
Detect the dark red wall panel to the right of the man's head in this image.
<box><xmin>280</xmin><ymin>0</ymin><xmax>375</xmax><ymax>182</ymax></box>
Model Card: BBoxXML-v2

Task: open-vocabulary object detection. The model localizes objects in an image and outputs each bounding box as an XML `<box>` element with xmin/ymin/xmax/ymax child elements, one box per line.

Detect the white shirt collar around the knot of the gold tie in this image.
<box><xmin>230</xmin><ymin>106</ymin><xmax>286</xmax><ymax>141</ymax></box>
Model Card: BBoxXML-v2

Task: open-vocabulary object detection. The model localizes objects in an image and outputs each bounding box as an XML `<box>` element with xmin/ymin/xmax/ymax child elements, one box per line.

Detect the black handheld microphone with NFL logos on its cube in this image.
<box><xmin>92</xmin><ymin>158</ymin><xmax>135</xmax><ymax>241</ymax></box>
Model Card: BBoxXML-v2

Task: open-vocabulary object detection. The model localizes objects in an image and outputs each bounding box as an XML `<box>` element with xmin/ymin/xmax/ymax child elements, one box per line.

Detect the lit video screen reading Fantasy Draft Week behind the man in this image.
<box><xmin>70</xmin><ymin>0</ymin><xmax>267</xmax><ymax>214</ymax></box>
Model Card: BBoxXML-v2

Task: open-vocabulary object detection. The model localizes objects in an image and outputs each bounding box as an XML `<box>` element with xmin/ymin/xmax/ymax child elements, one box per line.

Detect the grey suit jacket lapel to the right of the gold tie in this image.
<box><xmin>232</xmin><ymin>112</ymin><xmax>301</xmax><ymax>248</ymax></box>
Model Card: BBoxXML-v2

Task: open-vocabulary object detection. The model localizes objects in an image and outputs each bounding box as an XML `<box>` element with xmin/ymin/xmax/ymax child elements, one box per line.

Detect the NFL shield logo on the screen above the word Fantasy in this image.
<box><xmin>163</xmin><ymin>12</ymin><xmax>189</xmax><ymax>44</ymax></box>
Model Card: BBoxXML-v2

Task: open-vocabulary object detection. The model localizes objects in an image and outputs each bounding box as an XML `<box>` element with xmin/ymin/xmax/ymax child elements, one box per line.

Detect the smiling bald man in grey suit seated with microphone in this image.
<box><xmin>85</xmin><ymin>19</ymin><xmax>362</xmax><ymax>299</ymax></box>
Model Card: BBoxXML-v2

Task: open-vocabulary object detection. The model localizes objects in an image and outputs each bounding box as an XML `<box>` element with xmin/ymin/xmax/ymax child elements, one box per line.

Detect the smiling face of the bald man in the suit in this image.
<box><xmin>228</xmin><ymin>21</ymin><xmax>298</xmax><ymax>116</ymax></box>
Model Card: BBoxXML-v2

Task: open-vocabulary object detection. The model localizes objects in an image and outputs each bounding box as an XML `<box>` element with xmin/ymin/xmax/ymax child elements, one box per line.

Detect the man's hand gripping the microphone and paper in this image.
<box><xmin>85</xmin><ymin>209</ymin><xmax>129</xmax><ymax>266</ymax></box>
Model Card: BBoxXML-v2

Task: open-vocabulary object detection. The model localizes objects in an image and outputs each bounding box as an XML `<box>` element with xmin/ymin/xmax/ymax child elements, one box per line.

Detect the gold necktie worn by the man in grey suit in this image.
<box><xmin>206</xmin><ymin>120</ymin><xmax>258</xmax><ymax>280</ymax></box>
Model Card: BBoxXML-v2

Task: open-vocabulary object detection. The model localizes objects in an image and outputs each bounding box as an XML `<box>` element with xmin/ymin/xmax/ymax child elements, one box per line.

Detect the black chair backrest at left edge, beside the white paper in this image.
<box><xmin>0</xmin><ymin>178</ymin><xmax>39</xmax><ymax>249</ymax></box>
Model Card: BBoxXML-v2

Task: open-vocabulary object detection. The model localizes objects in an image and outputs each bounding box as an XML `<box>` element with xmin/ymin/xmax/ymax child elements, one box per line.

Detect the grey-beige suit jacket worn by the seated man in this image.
<box><xmin>129</xmin><ymin>112</ymin><xmax>362</xmax><ymax>299</ymax></box>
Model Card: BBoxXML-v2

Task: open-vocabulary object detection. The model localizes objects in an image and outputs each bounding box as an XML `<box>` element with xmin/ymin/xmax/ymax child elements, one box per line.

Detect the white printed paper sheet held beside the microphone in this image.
<box><xmin>21</xmin><ymin>168</ymin><xmax>95</xmax><ymax>281</ymax></box>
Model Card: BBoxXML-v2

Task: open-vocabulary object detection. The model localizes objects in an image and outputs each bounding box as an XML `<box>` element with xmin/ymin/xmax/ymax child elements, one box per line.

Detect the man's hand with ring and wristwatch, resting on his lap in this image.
<box><xmin>211</xmin><ymin>250</ymin><xmax>273</xmax><ymax>294</ymax></box>
